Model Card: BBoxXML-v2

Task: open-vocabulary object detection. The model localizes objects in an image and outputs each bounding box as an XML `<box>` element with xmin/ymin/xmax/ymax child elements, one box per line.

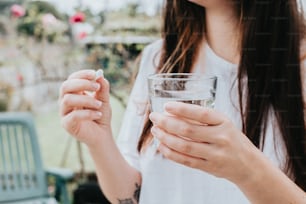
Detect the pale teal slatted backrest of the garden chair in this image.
<box><xmin>0</xmin><ymin>112</ymin><xmax>48</xmax><ymax>203</ymax></box>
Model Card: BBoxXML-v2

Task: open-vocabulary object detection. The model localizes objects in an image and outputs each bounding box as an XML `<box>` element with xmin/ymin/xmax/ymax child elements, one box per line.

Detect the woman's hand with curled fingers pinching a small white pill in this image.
<box><xmin>59</xmin><ymin>70</ymin><xmax>112</xmax><ymax>147</ymax></box>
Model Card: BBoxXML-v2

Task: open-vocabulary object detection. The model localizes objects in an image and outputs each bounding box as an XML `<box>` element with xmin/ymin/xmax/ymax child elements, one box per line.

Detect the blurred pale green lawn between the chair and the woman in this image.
<box><xmin>34</xmin><ymin>98</ymin><xmax>125</xmax><ymax>172</ymax></box>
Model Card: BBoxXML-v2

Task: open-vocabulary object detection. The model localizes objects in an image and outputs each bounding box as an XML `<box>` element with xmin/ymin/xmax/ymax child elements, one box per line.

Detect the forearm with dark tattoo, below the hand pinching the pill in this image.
<box><xmin>89</xmin><ymin>131</ymin><xmax>141</xmax><ymax>204</ymax></box>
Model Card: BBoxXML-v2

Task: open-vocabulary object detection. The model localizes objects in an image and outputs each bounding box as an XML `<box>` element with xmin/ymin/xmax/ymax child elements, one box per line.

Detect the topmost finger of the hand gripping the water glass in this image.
<box><xmin>165</xmin><ymin>102</ymin><xmax>224</xmax><ymax>125</ymax></box>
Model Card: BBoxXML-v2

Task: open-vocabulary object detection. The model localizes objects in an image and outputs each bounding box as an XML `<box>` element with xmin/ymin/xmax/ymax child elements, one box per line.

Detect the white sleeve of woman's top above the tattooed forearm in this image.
<box><xmin>117</xmin><ymin>40</ymin><xmax>161</xmax><ymax>170</ymax></box>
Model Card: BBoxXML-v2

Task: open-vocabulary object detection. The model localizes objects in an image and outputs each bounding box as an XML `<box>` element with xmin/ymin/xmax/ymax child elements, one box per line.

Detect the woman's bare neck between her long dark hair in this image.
<box><xmin>206</xmin><ymin>6</ymin><xmax>240</xmax><ymax>64</ymax></box>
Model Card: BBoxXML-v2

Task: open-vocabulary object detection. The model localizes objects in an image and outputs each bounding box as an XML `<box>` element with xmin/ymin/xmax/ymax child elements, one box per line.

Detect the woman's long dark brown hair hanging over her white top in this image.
<box><xmin>138</xmin><ymin>0</ymin><xmax>306</xmax><ymax>191</ymax></box>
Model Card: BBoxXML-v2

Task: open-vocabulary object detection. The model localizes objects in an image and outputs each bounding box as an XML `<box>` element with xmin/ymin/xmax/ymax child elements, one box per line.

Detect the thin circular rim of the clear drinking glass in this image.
<box><xmin>148</xmin><ymin>73</ymin><xmax>217</xmax><ymax>80</ymax></box>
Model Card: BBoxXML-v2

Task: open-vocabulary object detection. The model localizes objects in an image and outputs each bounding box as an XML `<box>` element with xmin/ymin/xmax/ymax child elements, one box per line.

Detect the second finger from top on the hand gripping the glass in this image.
<box><xmin>149</xmin><ymin>112</ymin><xmax>216</xmax><ymax>143</ymax></box>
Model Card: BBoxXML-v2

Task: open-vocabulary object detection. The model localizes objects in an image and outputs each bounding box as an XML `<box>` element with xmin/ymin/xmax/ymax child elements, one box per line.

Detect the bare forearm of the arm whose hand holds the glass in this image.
<box><xmin>236</xmin><ymin>147</ymin><xmax>306</xmax><ymax>204</ymax></box>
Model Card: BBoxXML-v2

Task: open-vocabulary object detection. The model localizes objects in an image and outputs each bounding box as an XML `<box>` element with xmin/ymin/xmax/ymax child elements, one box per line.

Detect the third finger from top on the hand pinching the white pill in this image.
<box><xmin>60</xmin><ymin>94</ymin><xmax>102</xmax><ymax>115</ymax></box>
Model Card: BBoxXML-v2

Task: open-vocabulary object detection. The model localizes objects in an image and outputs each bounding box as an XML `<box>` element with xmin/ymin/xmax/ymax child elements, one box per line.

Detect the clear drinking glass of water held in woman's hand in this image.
<box><xmin>148</xmin><ymin>73</ymin><xmax>217</xmax><ymax>152</ymax></box>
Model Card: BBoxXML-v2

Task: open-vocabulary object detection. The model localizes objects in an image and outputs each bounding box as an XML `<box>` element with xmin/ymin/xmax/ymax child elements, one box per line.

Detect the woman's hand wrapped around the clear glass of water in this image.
<box><xmin>150</xmin><ymin>102</ymin><xmax>261</xmax><ymax>183</ymax></box>
